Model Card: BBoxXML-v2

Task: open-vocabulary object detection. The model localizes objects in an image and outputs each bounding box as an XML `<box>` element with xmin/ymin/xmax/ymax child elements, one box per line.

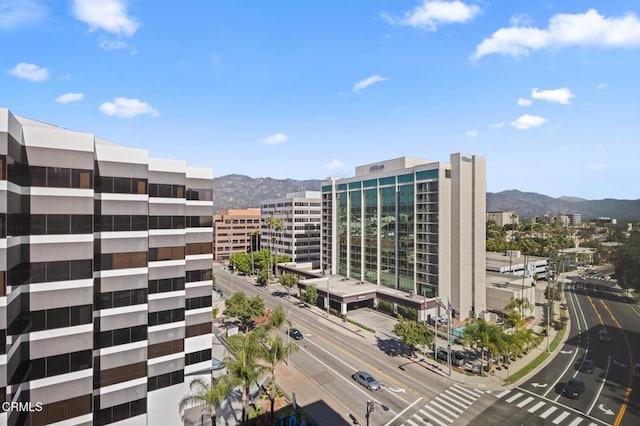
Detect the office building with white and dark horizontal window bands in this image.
<box><xmin>0</xmin><ymin>109</ymin><xmax>213</xmax><ymax>425</ymax></box>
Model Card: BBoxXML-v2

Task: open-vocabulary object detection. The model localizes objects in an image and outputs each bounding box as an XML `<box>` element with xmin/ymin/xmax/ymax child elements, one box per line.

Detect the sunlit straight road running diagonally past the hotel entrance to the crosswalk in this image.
<box><xmin>215</xmin><ymin>266</ymin><xmax>492</xmax><ymax>426</ymax></box>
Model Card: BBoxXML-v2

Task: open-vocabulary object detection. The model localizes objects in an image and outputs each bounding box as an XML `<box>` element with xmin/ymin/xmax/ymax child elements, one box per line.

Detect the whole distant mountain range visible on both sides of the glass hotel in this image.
<box><xmin>213</xmin><ymin>174</ymin><xmax>640</xmax><ymax>221</ymax></box>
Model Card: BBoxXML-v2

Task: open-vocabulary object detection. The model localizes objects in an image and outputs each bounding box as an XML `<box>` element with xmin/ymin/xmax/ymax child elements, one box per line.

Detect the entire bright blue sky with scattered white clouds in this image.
<box><xmin>0</xmin><ymin>0</ymin><xmax>640</xmax><ymax>199</ymax></box>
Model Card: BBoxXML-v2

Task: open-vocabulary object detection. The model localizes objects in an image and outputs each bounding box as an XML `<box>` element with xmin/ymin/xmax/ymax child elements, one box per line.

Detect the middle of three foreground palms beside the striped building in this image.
<box><xmin>224</xmin><ymin>331</ymin><xmax>267</xmax><ymax>425</ymax></box>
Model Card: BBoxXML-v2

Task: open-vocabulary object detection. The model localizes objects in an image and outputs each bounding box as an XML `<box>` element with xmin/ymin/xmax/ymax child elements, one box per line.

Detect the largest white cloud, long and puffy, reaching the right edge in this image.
<box><xmin>473</xmin><ymin>9</ymin><xmax>640</xmax><ymax>59</ymax></box>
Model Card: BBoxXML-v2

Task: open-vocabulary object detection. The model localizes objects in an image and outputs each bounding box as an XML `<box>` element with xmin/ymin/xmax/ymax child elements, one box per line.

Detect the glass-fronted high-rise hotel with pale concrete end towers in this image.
<box><xmin>321</xmin><ymin>154</ymin><xmax>486</xmax><ymax>318</ymax></box>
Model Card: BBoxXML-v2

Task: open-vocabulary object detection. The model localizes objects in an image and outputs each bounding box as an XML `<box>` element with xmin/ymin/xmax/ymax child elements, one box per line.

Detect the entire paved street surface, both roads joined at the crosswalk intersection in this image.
<box><xmin>211</xmin><ymin>270</ymin><xmax>640</xmax><ymax>426</ymax></box>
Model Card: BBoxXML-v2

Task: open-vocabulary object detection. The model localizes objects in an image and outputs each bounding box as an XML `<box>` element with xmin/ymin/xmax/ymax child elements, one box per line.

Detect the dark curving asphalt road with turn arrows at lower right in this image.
<box><xmin>482</xmin><ymin>280</ymin><xmax>640</xmax><ymax>426</ymax></box>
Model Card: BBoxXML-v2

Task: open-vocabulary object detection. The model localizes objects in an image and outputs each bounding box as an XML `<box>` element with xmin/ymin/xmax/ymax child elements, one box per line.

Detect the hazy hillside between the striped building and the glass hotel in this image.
<box><xmin>213</xmin><ymin>174</ymin><xmax>322</xmax><ymax>212</ymax></box>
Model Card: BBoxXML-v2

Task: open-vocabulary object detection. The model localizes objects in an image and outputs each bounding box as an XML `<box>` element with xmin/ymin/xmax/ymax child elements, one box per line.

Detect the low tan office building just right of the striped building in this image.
<box><xmin>213</xmin><ymin>209</ymin><xmax>260</xmax><ymax>261</ymax></box>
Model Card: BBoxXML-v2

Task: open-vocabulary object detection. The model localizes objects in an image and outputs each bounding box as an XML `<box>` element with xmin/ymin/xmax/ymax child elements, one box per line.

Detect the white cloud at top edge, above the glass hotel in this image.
<box><xmin>381</xmin><ymin>0</ymin><xmax>481</xmax><ymax>31</ymax></box>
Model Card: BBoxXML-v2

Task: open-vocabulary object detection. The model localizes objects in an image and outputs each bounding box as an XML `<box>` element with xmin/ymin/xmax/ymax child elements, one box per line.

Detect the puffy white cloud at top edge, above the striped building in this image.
<box><xmin>73</xmin><ymin>0</ymin><xmax>140</xmax><ymax>36</ymax></box>
